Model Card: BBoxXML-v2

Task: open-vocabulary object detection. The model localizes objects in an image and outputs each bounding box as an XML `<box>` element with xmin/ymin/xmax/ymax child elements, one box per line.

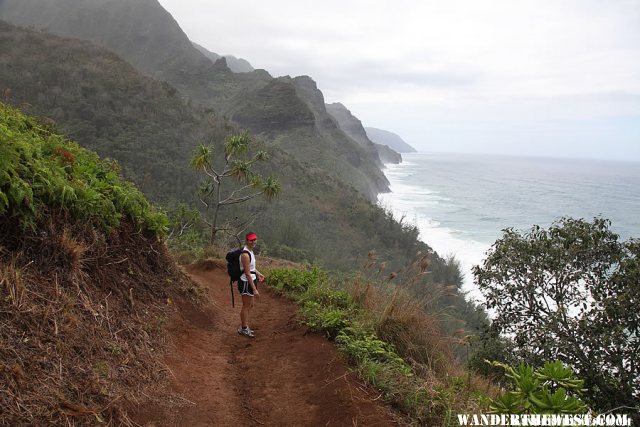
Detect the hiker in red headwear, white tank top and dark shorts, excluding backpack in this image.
<box><xmin>238</xmin><ymin>233</ymin><xmax>264</xmax><ymax>337</ymax></box>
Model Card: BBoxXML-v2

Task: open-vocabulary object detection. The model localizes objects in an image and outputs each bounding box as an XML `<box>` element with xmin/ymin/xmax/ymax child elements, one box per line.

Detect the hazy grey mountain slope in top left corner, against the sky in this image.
<box><xmin>0</xmin><ymin>0</ymin><xmax>211</xmax><ymax>81</ymax></box>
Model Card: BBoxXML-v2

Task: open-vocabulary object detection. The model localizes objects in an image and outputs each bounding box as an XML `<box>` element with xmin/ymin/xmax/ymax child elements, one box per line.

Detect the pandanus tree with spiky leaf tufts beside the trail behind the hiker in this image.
<box><xmin>191</xmin><ymin>132</ymin><xmax>280</xmax><ymax>243</ymax></box>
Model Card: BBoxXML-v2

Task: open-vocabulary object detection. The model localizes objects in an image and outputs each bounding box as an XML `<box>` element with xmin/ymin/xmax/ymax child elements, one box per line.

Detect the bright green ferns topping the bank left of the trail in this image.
<box><xmin>0</xmin><ymin>103</ymin><xmax>168</xmax><ymax>236</ymax></box>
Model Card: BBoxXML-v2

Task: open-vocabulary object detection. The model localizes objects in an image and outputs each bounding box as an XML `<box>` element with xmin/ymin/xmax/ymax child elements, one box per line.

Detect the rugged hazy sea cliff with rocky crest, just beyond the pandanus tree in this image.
<box><xmin>227</xmin><ymin>77</ymin><xmax>388</xmax><ymax>200</ymax></box>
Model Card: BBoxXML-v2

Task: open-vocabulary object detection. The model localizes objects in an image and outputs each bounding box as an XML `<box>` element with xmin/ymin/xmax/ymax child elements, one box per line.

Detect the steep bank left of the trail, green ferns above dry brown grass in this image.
<box><xmin>0</xmin><ymin>104</ymin><xmax>195</xmax><ymax>425</ymax></box>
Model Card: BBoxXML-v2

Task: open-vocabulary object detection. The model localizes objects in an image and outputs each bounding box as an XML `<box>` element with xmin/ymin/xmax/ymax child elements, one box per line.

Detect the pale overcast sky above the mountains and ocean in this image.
<box><xmin>159</xmin><ymin>0</ymin><xmax>640</xmax><ymax>161</ymax></box>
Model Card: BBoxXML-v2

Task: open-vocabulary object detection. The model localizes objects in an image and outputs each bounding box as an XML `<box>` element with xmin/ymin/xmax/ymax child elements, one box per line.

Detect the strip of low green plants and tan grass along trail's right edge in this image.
<box><xmin>267</xmin><ymin>268</ymin><xmax>489</xmax><ymax>426</ymax></box>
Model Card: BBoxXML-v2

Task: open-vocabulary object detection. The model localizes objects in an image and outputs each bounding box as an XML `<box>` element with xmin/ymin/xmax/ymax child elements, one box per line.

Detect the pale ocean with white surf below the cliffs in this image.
<box><xmin>379</xmin><ymin>153</ymin><xmax>640</xmax><ymax>301</ymax></box>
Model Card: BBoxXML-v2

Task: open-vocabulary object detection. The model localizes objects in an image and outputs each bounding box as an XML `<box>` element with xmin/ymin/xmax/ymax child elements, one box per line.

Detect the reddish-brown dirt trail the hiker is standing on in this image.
<box><xmin>134</xmin><ymin>263</ymin><xmax>397</xmax><ymax>426</ymax></box>
